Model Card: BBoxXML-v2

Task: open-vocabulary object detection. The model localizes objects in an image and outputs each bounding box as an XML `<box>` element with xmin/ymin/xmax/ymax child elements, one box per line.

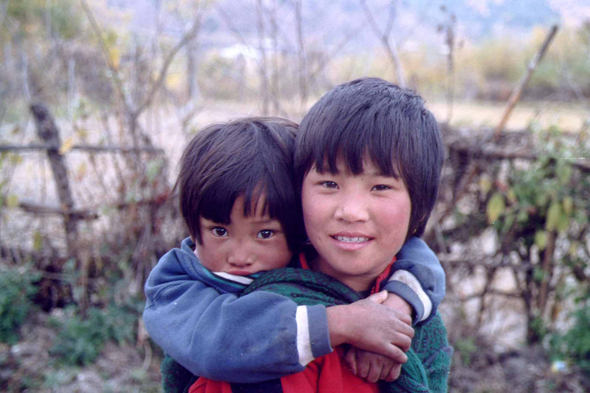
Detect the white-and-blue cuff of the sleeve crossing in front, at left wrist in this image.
<box><xmin>295</xmin><ymin>305</ymin><xmax>332</xmax><ymax>367</ymax></box>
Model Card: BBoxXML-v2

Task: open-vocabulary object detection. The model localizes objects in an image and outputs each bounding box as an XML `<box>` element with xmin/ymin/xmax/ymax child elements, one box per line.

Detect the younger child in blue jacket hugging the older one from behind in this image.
<box><xmin>144</xmin><ymin>115</ymin><xmax>444</xmax><ymax>388</ymax></box>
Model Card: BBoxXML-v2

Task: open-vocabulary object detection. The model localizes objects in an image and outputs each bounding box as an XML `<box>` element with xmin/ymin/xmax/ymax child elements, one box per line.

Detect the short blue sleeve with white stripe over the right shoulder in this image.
<box><xmin>384</xmin><ymin>237</ymin><xmax>445</xmax><ymax>324</ymax></box>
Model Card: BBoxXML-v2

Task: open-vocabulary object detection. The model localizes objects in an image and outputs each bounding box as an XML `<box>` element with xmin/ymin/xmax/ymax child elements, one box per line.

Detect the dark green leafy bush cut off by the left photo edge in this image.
<box><xmin>0</xmin><ymin>267</ymin><xmax>39</xmax><ymax>343</ymax></box>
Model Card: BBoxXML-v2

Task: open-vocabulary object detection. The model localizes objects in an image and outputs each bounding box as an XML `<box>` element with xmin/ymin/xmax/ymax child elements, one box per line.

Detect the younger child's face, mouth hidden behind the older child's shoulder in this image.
<box><xmin>195</xmin><ymin>196</ymin><xmax>292</xmax><ymax>275</ymax></box>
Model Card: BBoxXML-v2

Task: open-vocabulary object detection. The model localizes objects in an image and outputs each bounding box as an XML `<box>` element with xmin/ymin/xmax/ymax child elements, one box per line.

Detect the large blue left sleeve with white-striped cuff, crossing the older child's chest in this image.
<box><xmin>143</xmin><ymin>249</ymin><xmax>332</xmax><ymax>382</ymax></box>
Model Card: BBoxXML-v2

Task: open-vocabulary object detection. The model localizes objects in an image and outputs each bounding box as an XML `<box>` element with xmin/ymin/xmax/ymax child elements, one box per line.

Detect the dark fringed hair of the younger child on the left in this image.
<box><xmin>175</xmin><ymin>117</ymin><xmax>304</xmax><ymax>252</ymax></box>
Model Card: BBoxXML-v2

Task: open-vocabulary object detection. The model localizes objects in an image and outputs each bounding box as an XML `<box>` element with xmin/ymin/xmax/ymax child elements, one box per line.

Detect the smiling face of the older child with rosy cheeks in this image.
<box><xmin>301</xmin><ymin>156</ymin><xmax>412</xmax><ymax>291</ymax></box>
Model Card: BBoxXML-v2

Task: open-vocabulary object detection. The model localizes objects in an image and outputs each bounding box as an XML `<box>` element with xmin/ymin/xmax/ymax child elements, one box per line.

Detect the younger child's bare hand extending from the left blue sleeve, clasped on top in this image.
<box><xmin>327</xmin><ymin>291</ymin><xmax>414</xmax><ymax>363</ymax></box>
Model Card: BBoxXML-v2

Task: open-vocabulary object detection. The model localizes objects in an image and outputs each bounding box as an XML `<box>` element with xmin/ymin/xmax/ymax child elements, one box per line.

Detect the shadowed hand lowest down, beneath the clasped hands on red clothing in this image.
<box><xmin>344</xmin><ymin>347</ymin><xmax>402</xmax><ymax>383</ymax></box>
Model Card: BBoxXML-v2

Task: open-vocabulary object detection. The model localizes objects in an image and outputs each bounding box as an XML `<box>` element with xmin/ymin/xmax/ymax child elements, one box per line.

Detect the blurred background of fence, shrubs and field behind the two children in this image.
<box><xmin>0</xmin><ymin>0</ymin><xmax>590</xmax><ymax>392</ymax></box>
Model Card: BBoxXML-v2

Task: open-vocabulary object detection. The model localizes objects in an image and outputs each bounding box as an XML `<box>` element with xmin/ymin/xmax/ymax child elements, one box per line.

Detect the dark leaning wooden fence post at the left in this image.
<box><xmin>30</xmin><ymin>103</ymin><xmax>78</xmax><ymax>257</ymax></box>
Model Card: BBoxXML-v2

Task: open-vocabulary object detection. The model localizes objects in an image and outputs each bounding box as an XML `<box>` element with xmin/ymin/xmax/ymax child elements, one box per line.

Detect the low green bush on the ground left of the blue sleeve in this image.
<box><xmin>50</xmin><ymin>305</ymin><xmax>138</xmax><ymax>365</ymax></box>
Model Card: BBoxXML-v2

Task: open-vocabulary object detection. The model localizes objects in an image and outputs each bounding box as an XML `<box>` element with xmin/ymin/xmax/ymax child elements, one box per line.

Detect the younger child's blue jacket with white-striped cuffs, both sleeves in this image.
<box><xmin>143</xmin><ymin>238</ymin><xmax>445</xmax><ymax>382</ymax></box>
